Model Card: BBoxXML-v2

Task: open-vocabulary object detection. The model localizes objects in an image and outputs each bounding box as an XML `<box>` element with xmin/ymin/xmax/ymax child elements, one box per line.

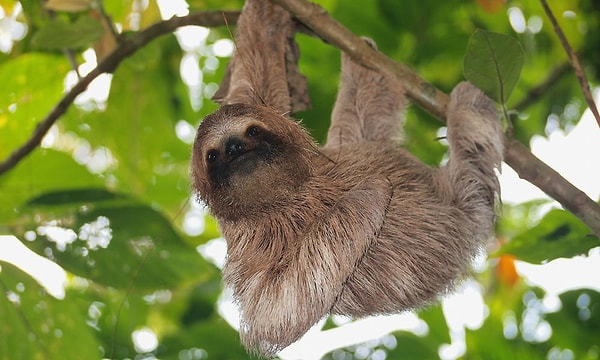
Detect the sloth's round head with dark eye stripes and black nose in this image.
<box><xmin>191</xmin><ymin>104</ymin><xmax>316</xmax><ymax>220</ymax></box>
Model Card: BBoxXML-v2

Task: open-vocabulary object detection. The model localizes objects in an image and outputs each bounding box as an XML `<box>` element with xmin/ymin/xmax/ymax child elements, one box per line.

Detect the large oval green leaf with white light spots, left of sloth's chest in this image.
<box><xmin>14</xmin><ymin>189</ymin><xmax>215</xmax><ymax>290</ymax></box>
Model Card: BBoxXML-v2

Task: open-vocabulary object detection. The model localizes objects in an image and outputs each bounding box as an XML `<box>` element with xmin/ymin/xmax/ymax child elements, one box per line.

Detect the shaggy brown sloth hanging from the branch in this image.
<box><xmin>191</xmin><ymin>0</ymin><xmax>503</xmax><ymax>357</ymax></box>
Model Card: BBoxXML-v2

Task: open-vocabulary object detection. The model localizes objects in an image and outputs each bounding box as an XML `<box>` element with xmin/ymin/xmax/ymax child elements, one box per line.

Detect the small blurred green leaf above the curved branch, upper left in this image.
<box><xmin>31</xmin><ymin>15</ymin><xmax>104</xmax><ymax>50</ymax></box>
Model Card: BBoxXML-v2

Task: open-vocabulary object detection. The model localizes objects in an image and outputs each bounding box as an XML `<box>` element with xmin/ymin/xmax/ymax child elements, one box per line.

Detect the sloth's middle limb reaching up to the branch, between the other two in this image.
<box><xmin>326</xmin><ymin>39</ymin><xmax>407</xmax><ymax>147</ymax></box>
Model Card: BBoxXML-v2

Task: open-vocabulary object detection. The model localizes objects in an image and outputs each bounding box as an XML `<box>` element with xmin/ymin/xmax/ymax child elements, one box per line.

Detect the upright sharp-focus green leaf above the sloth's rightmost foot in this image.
<box><xmin>464</xmin><ymin>29</ymin><xmax>523</xmax><ymax>104</ymax></box>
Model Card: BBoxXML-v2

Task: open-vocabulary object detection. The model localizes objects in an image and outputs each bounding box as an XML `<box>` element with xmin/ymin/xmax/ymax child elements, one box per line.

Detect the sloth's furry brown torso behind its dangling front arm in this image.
<box><xmin>318</xmin><ymin>142</ymin><xmax>481</xmax><ymax>316</ymax></box>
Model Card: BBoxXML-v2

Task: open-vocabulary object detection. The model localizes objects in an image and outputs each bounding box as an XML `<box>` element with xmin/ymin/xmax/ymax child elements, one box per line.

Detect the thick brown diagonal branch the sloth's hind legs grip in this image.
<box><xmin>272</xmin><ymin>0</ymin><xmax>600</xmax><ymax>236</ymax></box>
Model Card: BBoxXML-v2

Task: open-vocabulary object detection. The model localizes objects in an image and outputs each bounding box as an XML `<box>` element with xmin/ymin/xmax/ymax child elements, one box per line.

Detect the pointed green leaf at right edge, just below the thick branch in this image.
<box><xmin>498</xmin><ymin>209</ymin><xmax>600</xmax><ymax>263</ymax></box>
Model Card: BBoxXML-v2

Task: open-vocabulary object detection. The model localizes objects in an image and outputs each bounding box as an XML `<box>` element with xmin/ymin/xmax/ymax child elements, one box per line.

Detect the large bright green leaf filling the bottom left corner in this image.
<box><xmin>0</xmin><ymin>263</ymin><xmax>101</xmax><ymax>359</ymax></box>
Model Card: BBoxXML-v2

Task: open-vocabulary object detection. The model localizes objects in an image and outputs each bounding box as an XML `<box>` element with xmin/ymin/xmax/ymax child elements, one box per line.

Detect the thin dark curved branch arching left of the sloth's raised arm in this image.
<box><xmin>0</xmin><ymin>11</ymin><xmax>240</xmax><ymax>174</ymax></box>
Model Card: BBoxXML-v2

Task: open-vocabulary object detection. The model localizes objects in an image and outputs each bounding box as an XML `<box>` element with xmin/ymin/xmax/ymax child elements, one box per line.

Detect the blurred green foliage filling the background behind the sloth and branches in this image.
<box><xmin>0</xmin><ymin>0</ymin><xmax>600</xmax><ymax>359</ymax></box>
